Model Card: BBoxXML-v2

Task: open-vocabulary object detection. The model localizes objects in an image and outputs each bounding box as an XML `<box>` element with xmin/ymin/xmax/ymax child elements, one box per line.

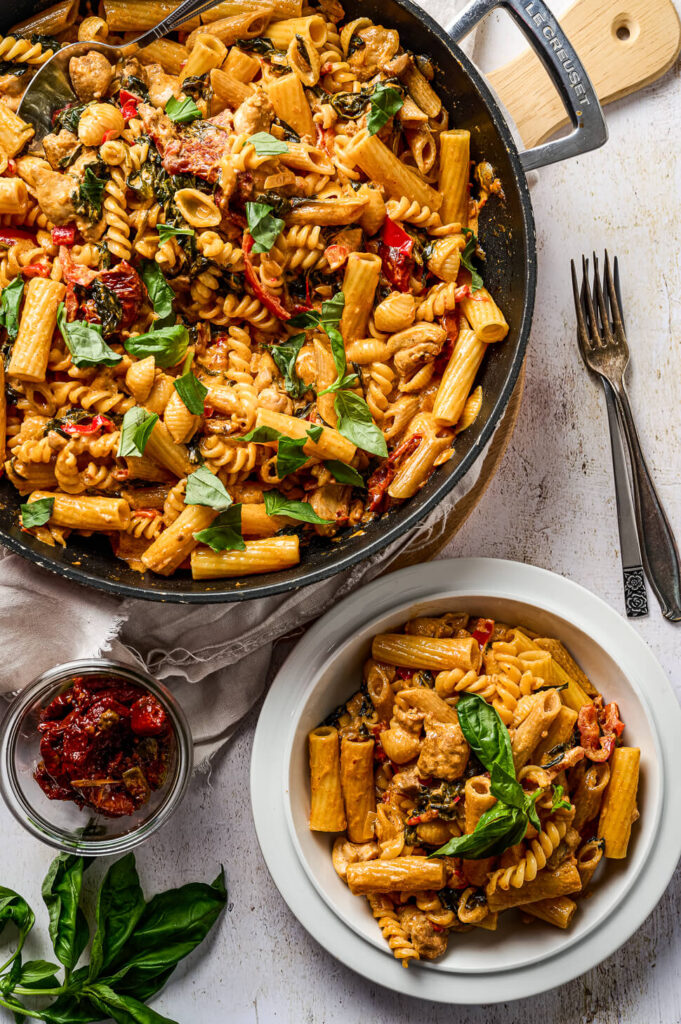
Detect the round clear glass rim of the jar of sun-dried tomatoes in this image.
<box><xmin>0</xmin><ymin>657</ymin><xmax>194</xmax><ymax>857</ymax></box>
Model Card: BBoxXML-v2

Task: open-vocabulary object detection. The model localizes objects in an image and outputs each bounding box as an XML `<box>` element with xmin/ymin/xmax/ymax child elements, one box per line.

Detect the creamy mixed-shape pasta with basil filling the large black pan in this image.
<box><xmin>0</xmin><ymin>0</ymin><xmax>508</xmax><ymax>580</ymax></box>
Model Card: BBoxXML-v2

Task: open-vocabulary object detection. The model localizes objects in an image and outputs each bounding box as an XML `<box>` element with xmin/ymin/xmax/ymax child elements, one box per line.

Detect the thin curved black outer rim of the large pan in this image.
<box><xmin>0</xmin><ymin>0</ymin><xmax>537</xmax><ymax>604</ymax></box>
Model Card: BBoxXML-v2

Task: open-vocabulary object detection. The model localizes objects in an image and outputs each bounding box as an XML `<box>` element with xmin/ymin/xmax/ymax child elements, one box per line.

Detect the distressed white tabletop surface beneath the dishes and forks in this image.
<box><xmin>0</xmin><ymin>0</ymin><xmax>681</xmax><ymax>1024</ymax></box>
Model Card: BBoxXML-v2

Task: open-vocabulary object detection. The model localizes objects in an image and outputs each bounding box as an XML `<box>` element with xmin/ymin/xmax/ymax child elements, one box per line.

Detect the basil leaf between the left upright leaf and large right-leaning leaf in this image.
<box><xmin>88</xmin><ymin>853</ymin><xmax>145</xmax><ymax>981</ymax></box>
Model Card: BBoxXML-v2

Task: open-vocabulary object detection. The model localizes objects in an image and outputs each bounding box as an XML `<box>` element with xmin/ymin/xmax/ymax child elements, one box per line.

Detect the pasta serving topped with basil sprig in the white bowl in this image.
<box><xmin>308</xmin><ymin>612</ymin><xmax>640</xmax><ymax>967</ymax></box>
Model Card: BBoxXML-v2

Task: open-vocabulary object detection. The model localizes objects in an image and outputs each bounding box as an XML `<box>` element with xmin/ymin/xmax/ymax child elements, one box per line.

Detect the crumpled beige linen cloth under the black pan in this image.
<box><xmin>0</xmin><ymin>0</ymin><xmax>493</xmax><ymax>763</ymax></box>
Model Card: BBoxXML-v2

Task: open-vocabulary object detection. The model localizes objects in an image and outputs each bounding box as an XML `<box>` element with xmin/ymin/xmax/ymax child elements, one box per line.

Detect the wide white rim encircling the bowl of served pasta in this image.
<box><xmin>251</xmin><ymin>558</ymin><xmax>681</xmax><ymax>1002</ymax></box>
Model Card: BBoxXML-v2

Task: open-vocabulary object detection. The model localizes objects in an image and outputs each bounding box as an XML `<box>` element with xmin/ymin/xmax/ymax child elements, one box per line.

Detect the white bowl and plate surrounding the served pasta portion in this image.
<box><xmin>251</xmin><ymin>558</ymin><xmax>681</xmax><ymax>1002</ymax></box>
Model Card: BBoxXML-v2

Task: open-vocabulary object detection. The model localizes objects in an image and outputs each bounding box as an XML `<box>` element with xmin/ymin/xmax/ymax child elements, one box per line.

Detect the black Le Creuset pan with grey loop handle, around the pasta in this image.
<box><xmin>0</xmin><ymin>0</ymin><xmax>606</xmax><ymax>603</ymax></box>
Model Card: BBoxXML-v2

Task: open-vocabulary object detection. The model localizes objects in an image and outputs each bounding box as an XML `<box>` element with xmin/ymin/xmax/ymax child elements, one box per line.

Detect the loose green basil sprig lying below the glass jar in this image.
<box><xmin>0</xmin><ymin>853</ymin><xmax>227</xmax><ymax>1024</ymax></box>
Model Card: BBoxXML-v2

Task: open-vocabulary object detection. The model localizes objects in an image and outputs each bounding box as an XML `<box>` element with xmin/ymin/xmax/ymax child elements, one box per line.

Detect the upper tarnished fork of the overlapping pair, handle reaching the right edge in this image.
<box><xmin>571</xmin><ymin>252</ymin><xmax>681</xmax><ymax>622</ymax></box>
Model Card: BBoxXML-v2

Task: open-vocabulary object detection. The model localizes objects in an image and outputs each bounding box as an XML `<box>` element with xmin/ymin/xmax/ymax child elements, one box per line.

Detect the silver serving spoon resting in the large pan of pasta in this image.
<box><xmin>17</xmin><ymin>0</ymin><xmax>220</xmax><ymax>147</ymax></box>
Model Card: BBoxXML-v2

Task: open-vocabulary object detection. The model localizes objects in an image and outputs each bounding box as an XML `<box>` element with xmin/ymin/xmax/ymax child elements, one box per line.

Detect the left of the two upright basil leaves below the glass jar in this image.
<box><xmin>42</xmin><ymin>853</ymin><xmax>91</xmax><ymax>971</ymax></box>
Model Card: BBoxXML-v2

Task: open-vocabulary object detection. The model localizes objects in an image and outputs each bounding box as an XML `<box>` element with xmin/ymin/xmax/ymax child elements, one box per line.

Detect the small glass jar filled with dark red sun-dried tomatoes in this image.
<box><xmin>0</xmin><ymin>658</ymin><xmax>193</xmax><ymax>857</ymax></box>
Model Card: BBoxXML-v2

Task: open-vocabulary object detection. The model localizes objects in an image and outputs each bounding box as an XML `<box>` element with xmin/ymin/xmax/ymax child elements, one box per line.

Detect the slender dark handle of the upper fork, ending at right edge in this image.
<box><xmin>610</xmin><ymin>379</ymin><xmax>681</xmax><ymax>623</ymax></box>
